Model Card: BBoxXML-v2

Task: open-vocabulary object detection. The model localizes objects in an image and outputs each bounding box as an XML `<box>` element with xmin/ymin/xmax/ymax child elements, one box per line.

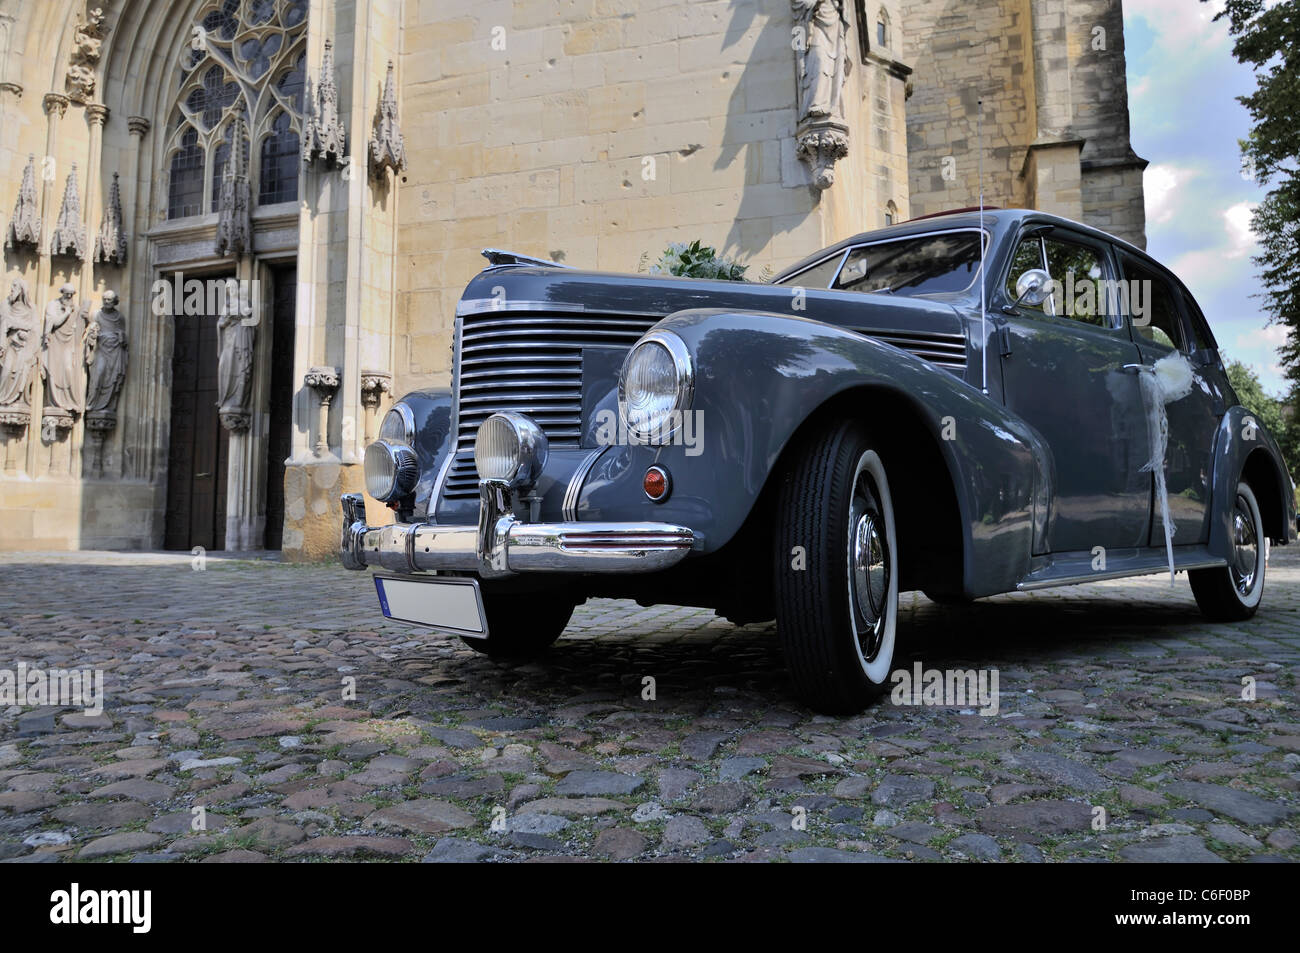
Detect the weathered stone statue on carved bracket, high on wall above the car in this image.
<box><xmin>790</xmin><ymin>0</ymin><xmax>849</xmax><ymax>190</ymax></box>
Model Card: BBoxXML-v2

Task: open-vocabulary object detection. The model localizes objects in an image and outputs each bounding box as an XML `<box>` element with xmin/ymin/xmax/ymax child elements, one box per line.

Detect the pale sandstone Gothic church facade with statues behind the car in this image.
<box><xmin>0</xmin><ymin>0</ymin><xmax>1145</xmax><ymax>559</ymax></box>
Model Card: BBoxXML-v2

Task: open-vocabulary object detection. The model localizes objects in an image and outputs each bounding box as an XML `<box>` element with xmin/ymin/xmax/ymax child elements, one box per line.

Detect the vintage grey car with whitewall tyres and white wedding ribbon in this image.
<box><xmin>342</xmin><ymin>209</ymin><xmax>1295</xmax><ymax>712</ymax></box>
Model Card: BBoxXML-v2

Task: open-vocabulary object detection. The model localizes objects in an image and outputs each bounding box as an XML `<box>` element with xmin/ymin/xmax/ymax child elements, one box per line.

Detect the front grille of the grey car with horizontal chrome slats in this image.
<box><xmin>442</xmin><ymin>311</ymin><xmax>658</xmax><ymax>499</ymax></box>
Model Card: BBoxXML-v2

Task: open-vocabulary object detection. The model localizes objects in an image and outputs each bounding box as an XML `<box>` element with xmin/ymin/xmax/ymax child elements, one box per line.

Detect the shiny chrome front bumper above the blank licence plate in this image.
<box><xmin>339</xmin><ymin>480</ymin><xmax>696</xmax><ymax>579</ymax></box>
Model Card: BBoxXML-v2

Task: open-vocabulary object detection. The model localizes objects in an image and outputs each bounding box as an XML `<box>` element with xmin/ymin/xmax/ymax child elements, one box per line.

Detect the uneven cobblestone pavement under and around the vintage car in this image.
<box><xmin>0</xmin><ymin>546</ymin><xmax>1300</xmax><ymax>862</ymax></box>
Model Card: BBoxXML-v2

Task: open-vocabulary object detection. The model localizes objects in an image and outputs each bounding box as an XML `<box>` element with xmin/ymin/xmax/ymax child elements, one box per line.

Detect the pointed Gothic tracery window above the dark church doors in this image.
<box><xmin>165</xmin><ymin>0</ymin><xmax>309</xmax><ymax>218</ymax></box>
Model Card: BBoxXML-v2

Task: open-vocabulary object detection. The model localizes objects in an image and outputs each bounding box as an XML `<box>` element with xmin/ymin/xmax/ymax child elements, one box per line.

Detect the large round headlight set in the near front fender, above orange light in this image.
<box><xmin>619</xmin><ymin>329</ymin><xmax>696</xmax><ymax>443</ymax></box>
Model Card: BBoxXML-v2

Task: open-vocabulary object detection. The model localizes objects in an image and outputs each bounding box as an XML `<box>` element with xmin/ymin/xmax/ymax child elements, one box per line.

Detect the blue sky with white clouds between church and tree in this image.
<box><xmin>1123</xmin><ymin>0</ymin><xmax>1286</xmax><ymax>395</ymax></box>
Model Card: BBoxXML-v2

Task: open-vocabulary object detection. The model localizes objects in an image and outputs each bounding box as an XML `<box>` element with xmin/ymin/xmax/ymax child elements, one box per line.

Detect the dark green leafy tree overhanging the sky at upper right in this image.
<box><xmin>1203</xmin><ymin>0</ymin><xmax>1300</xmax><ymax>387</ymax></box>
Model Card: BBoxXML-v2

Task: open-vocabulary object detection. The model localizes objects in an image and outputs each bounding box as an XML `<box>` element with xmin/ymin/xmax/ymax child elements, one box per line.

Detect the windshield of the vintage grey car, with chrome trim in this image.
<box><xmin>777</xmin><ymin>231</ymin><xmax>980</xmax><ymax>295</ymax></box>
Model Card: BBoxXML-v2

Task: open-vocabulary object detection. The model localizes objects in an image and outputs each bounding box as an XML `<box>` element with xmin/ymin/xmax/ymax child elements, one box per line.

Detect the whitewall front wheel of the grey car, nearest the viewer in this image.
<box><xmin>775</xmin><ymin>423</ymin><xmax>898</xmax><ymax>715</ymax></box>
